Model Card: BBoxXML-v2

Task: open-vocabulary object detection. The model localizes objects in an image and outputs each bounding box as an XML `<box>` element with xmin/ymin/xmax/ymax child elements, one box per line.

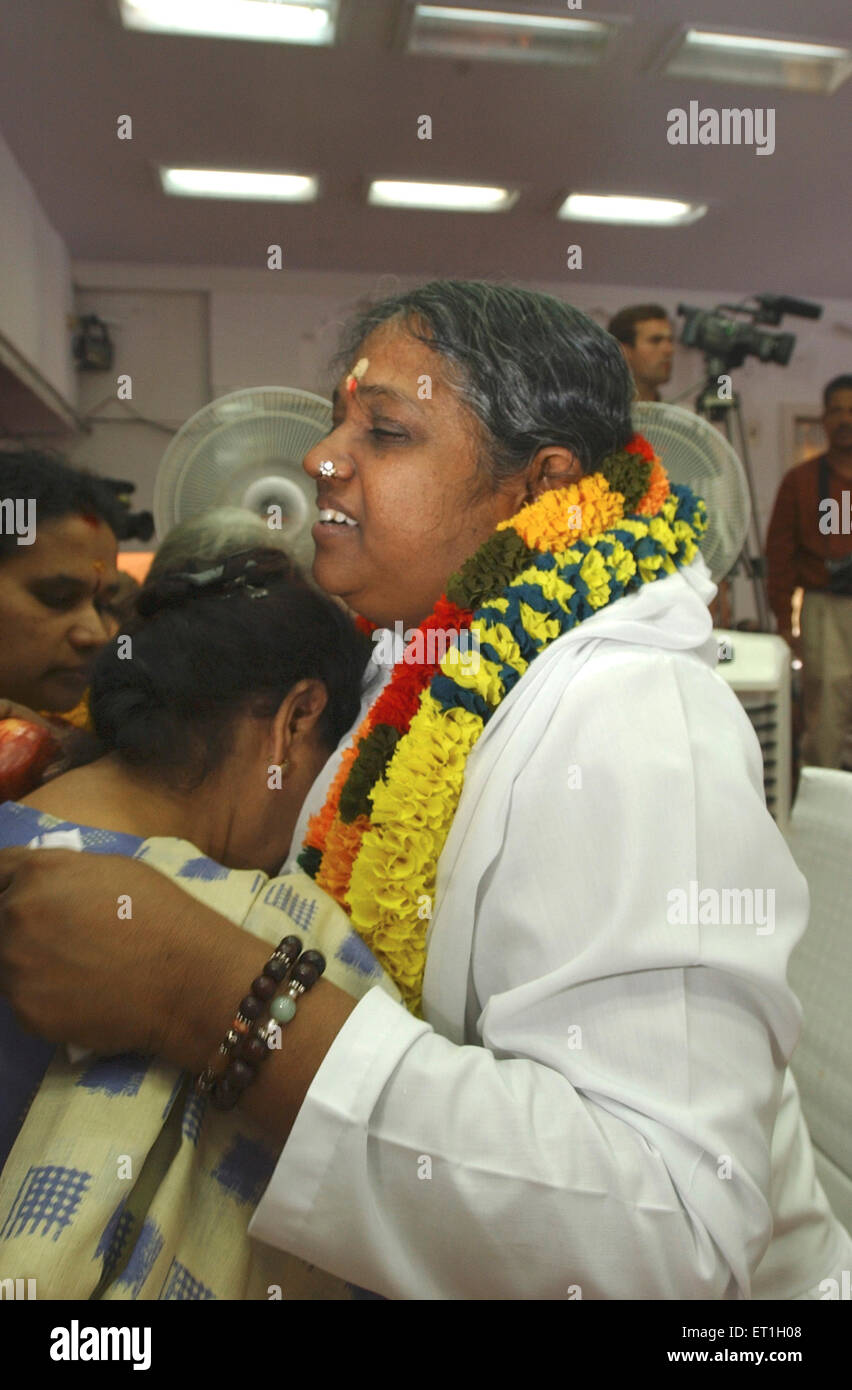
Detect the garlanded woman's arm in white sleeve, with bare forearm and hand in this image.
<box><xmin>0</xmin><ymin>653</ymin><xmax>806</xmax><ymax>1298</ymax></box>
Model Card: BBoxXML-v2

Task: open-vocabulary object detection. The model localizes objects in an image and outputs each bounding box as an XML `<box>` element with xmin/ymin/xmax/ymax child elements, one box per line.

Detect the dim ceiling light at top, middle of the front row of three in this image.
<box><xmin>407</xmin><ymin>4</ymin><xmax>614</xmax><ymax>65</ymax></box>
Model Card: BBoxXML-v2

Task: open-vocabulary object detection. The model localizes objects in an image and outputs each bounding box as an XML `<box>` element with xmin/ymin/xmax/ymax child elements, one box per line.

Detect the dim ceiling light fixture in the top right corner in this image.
<box><xmin>664</xmin><ymin>28</ymin><xmax>852</xmax><ymax>95</ymax></box>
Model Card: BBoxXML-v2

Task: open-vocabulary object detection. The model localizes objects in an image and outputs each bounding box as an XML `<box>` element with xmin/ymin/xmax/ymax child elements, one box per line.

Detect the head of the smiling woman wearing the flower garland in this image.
<box><xmin>304</xmin><ymin>281</ymin><xmax>634</xmax><ymax>624</ymax></box>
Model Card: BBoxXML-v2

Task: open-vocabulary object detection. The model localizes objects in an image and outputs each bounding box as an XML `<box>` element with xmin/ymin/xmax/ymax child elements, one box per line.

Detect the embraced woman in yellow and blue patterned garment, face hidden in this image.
<box><xmin>0</xmin><ymin>544</ymin><xmax>399</xmax><ymax>1300</ymax></box>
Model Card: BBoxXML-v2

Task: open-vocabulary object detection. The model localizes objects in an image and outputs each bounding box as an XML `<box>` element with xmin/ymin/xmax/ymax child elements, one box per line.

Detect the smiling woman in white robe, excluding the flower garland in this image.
<box><xmin>0</xmin><ymin>276</ymin><xmax>852</xmax><ymax>1300</ymax></box>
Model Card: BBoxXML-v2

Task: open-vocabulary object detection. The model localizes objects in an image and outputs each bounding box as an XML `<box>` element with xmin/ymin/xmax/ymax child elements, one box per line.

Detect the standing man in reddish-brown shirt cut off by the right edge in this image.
<box><xmin>766</xmin><ymin>374</ymin><xmax>852</xmax><ymax>771</ymax></box>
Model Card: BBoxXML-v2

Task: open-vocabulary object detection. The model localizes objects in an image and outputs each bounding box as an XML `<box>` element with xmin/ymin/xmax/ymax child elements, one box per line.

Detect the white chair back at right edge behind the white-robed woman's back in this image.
<box><xmin>787</xmin><ymin>767</ymin><xmax>852</xmax><ymax>1230</ymax></box>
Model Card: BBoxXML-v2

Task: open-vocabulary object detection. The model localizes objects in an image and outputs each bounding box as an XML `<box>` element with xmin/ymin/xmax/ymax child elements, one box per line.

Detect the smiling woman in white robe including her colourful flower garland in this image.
<box><xmin>0</xmin><ymin>282</ymin><xmax>852</xmax><ymax>1300</ymax></box>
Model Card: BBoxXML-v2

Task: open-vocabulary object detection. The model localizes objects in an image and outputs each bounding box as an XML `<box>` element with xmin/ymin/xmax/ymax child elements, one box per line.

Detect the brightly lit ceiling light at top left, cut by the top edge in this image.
<box><xmin>120</xmin><ymin>0</ymin><xmax>338</xmax><ymax>43</ymax></box>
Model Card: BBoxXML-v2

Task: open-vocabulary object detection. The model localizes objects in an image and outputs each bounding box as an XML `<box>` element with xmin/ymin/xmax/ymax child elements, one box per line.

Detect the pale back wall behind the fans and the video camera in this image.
<box><xmin>66</xmin><ymin>263</ymin><xmax>852</xmax><ymax>617</ymax></box>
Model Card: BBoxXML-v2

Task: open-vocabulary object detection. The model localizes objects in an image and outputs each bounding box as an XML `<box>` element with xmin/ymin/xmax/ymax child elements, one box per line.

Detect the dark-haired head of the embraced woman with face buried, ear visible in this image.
<box><xmin>90</xmin><ymin>549</ymin><xmax>370</xmax><ymax>872</ymax></box>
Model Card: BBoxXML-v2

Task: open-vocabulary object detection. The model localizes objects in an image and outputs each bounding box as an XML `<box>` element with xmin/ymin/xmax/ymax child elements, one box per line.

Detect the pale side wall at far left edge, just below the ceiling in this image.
<box><xmin>0</xmin><ymin>125</ymin><xmax>76</xmax><ymax>404</ymax></box>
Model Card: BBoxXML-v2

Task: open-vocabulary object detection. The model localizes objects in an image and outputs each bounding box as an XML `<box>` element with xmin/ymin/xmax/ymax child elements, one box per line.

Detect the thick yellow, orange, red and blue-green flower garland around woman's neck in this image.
<box><xmin>299</xmin><ymin>435</ymin><xmax>707</xmax><ymax>1013</ymax></box>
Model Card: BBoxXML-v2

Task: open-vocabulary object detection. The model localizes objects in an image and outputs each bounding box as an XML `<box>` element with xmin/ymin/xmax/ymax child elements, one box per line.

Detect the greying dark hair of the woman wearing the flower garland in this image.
<box><xmin>335</xmin><ymin>279</ymin><xmax>634</xmax><ymax>488</ymax></box>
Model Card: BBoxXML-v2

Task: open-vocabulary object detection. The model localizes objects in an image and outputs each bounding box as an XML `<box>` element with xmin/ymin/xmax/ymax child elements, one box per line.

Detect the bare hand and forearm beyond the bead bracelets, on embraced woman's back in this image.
<box><xmin>0</xmin><ymin>849</ymin><xmax>257</xmax><ymax>1069</ymax></box>
